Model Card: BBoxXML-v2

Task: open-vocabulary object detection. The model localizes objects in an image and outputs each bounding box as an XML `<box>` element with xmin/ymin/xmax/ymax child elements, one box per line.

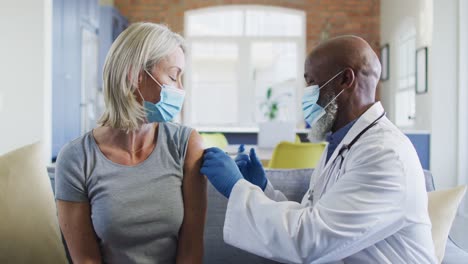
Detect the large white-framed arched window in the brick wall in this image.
<box><xmin>183</xmin><ymin>5</ymin><xmax>305</xmax><ymax>128</ymax></box>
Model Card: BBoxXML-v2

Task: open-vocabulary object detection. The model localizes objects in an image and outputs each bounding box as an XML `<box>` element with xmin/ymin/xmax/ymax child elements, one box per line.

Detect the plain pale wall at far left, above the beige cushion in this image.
<box><xmin>0</xmin><ymin>0</ymin><xmax>52</xmax><ymax>160</ymax></box>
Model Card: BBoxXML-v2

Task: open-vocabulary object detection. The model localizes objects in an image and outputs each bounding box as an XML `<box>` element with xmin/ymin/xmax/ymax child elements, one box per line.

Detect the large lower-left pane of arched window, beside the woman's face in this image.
<box><xmin>190</xmin><ymin>43</ymin><xmax>238</xmax><ymax>125</ymax></box>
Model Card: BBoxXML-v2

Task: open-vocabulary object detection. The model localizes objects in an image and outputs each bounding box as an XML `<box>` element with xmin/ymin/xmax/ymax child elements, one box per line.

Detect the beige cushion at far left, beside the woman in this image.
<box><xmin>0</xmin><ymin>144</ymin><xmax>67</xmax><ymax>263</ymax></box>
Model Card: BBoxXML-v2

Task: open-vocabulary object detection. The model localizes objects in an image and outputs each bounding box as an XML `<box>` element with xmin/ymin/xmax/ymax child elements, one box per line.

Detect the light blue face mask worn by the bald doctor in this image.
<box><xmin>302</xmin><ymin>71</ymin><xmax>344</xmax><ymax>126</ymax></box>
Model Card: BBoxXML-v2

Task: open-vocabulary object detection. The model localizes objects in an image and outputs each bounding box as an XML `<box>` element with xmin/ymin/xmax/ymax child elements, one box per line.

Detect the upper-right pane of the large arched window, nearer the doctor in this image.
<box><xmin>246</xmin><ymin>10</ymin><xmax>303</xmax><ymax>36</ymax></box>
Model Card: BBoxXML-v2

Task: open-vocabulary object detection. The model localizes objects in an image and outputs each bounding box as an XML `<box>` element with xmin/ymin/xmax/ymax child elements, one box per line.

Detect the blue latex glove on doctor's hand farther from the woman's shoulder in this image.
<box><xmin>235</xmin><ymin>145</ymin><xmax>268</xmax><ymax>191</ymax></box>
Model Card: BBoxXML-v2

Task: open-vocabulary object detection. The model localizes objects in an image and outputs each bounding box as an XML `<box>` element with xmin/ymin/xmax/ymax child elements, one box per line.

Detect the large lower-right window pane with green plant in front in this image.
<box><xmin>251</xmin><ymin>42</ymin><xmax>298</xmax><ymax>122</ymax></box>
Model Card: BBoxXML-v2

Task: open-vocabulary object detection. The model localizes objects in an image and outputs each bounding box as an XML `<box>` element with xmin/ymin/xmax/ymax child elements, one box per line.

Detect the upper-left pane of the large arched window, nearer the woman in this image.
<box><xmin>187</xmin><ymin>10</ymin><xmax>244</xmax><ymax>36</ymax></box>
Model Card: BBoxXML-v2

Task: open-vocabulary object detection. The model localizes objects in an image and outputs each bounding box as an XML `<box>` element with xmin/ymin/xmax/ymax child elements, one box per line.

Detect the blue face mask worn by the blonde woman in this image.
<box><xmin>138</xmin><ymin>70</ymin><xmax>185</xmax><ymax>123</ymax></box>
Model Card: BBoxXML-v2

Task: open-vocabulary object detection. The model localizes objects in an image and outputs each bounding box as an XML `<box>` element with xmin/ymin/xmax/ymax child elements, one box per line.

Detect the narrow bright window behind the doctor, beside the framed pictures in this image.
<box><xmin>395</xmin><ymin>27</ymin><xmax>416</xmax><ymax>127</ymax></box>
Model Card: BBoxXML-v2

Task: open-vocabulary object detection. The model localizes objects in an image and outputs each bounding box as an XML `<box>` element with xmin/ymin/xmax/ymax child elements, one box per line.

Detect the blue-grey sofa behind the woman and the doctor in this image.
<box><xmin>49</xmin><ymin>168</ymin><xmax>468</xmax><ymax>264</ymax></box>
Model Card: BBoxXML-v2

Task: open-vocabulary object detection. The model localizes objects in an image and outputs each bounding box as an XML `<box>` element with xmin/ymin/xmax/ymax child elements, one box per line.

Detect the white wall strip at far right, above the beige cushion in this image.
<box><xmin>429</xmin><ymin>0</ymin><xmax>468</xmax><ymax>188</ymax></box>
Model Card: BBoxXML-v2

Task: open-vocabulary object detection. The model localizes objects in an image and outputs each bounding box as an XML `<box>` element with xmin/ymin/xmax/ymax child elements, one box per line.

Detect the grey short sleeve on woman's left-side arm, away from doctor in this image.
<box><xmin>55</xmin><ymin>144</ymin><xmax>88</xmax><ymax>202</ymax></box>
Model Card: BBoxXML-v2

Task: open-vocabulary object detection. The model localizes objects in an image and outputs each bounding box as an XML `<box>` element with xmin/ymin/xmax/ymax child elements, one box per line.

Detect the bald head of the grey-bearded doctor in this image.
<box><xmin>304</xmin><ymin>36</ymin><xmax>381</xmax><ymax>131</ymax></box>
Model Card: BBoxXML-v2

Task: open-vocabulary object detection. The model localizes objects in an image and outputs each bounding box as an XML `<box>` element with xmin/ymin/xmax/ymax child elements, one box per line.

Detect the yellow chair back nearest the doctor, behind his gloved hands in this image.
<box><xmin>268</xmin><ymin>141</ymin><xmax>326</xmax><ymax>169</ymax></box>
